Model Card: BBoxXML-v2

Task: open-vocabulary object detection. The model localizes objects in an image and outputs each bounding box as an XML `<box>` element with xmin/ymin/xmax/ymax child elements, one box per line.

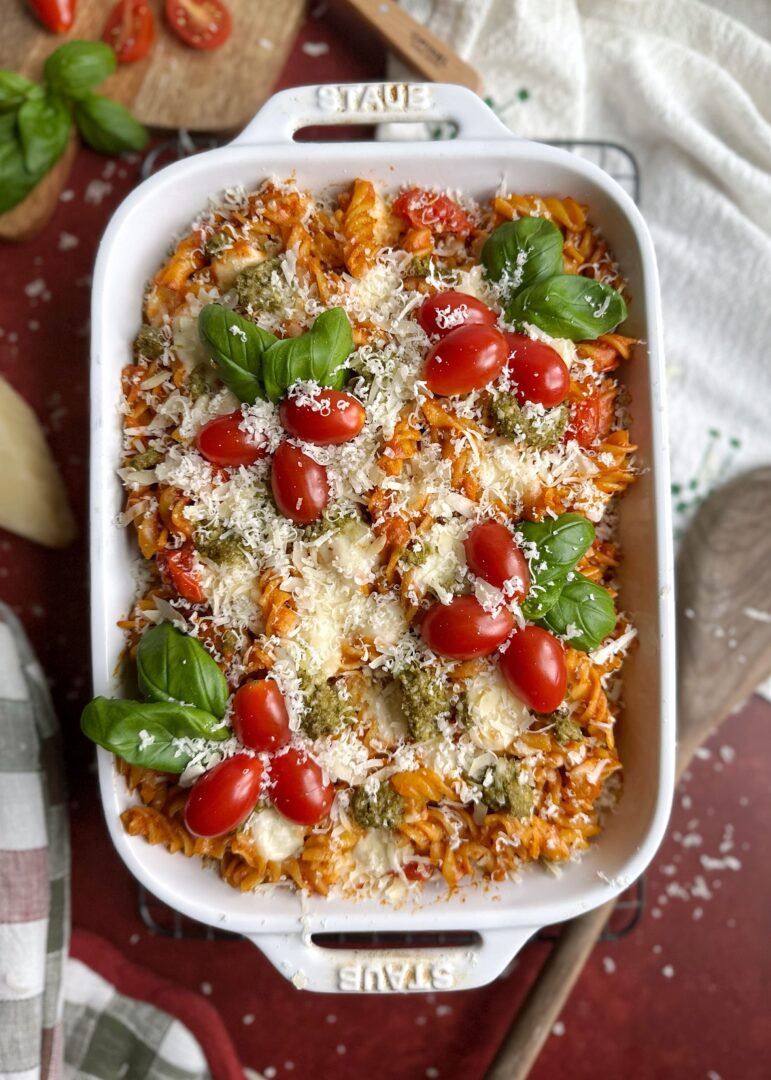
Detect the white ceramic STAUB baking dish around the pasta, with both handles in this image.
<box><xmin>91</xmin><ymin>83</ymin><xmax>675</xmax><ymax>991</ymax></box>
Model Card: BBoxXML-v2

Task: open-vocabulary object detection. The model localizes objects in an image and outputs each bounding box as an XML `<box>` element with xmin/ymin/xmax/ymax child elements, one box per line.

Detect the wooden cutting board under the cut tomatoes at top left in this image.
<box><xmin>0</xmin><ymin>0</ymin><xmax>303</xmax><ymax>131</ymax></box>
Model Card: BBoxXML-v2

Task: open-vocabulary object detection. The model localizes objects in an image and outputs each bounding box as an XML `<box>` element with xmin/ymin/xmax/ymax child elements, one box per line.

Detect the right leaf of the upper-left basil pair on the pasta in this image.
<box><xmin>262</xmin><ymin>308</ymin><xmax>353</xmax><ymax>402</ymax></box>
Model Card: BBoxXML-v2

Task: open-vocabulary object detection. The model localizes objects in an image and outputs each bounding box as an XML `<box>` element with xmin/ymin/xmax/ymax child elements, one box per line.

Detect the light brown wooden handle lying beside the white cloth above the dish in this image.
<box><xmin>336</xmin><ymin>0</ymin><xmax>482</xmax><ymax>93</ymax></box>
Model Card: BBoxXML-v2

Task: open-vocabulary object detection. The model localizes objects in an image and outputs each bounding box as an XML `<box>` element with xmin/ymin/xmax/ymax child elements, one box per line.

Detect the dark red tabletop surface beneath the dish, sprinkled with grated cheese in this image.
<box><xmin>0</xmin><ymin>10</ymin><xmax>771</xmax><ymax>1080</ymax></box>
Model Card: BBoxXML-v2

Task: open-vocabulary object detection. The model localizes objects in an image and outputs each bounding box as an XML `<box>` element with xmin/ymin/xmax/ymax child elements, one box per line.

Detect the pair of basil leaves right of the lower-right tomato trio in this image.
<box><xmin>517</xmin><ymin>513</ymin><xmax>616</xmax><ymax>651</ymax></box>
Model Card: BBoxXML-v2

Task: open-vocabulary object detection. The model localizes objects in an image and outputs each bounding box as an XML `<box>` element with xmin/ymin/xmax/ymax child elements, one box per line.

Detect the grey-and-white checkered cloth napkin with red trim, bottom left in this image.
<box><xmin>0</xmin><ymin>605</ymin><xmax>244</xmax><ymax>1080</ymax></box>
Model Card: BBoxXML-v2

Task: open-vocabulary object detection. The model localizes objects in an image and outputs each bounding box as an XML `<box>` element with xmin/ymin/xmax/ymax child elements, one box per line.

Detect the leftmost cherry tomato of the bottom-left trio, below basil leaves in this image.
<box><xmin>185</xmin><ymin>754</ymin><xmax>263</xmax><ymax>836</ymax></box>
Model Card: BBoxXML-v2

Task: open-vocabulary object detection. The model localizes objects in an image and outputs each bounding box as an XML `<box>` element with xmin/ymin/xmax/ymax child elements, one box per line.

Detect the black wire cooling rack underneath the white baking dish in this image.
<box><xmin>137</xmin><ymin>131</ymin><xmax>646</xmax><ymax>948</ymax></box>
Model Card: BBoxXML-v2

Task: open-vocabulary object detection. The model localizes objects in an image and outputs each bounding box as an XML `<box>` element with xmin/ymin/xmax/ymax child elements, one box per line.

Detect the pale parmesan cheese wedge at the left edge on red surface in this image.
<box><xmin>0</xmin><ymin>379</ymin><xmax>76</xmax><ymax>548</ymax></box>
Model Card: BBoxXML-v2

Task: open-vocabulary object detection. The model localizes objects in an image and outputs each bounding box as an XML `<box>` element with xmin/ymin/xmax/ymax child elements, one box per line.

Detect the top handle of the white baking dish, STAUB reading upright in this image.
<box><xmin>230</xmin><ymin>82</ymin><xmax>512</xmax><ymax>146</ymax></box>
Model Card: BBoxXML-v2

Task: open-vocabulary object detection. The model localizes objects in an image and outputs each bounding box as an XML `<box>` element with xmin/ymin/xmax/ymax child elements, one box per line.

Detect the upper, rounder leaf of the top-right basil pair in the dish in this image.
<box><xmin>481</xmin><ymin>217</ymin><xmax>563</xmax><ymax>299</ymax></box>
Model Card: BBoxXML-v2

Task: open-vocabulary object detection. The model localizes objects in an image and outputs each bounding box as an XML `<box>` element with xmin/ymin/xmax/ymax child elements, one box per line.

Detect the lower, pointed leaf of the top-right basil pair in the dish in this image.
<box><xmin>506</xmin><ymin>273</ymin><xmax>626</xmax><ymax>341</ymax></box>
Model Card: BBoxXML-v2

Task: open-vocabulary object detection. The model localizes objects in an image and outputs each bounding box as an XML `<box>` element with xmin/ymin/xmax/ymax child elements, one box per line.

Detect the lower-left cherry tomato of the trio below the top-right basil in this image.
<box><xmin>423</xmin><ymin>323</ymin><xmax>508</xmax><ymax>396</ymax></box>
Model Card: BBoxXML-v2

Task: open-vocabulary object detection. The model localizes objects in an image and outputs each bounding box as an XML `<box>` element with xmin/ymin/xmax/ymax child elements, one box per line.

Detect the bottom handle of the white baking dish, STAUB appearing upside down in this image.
<box><xmin>246</xmin><ymin>927</ymin><xmax>538</xmax><ymax>994</ymax></box>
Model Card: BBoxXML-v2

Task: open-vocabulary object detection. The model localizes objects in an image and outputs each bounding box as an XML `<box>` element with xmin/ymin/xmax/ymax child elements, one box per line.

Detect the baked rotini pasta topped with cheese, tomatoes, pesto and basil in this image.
<box><xmin>82</xmin><ymin>179</ymin><xmax>635</xmax><ymax>902</ymax></box>
